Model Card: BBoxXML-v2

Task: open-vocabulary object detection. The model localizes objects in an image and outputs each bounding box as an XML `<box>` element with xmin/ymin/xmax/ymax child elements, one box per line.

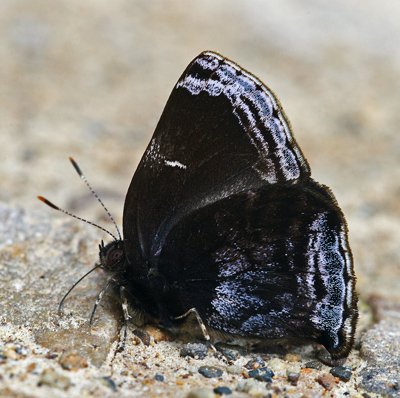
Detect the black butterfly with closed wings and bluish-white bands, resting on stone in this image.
<box><xmin>40</xmin><ymin>52</ymin><xmax>358</xmax><ymax>359</ymax></box>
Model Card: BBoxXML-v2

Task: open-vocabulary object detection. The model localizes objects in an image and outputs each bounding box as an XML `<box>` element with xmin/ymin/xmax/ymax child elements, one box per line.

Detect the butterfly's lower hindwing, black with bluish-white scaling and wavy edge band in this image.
<box><xmin>158</xmin><ymin>181</ymin><xmax>357</xmax><ymax>355</ymax></box>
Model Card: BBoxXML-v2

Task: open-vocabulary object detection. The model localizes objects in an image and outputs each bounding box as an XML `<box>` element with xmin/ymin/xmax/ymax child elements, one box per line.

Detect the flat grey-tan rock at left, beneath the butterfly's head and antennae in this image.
<box><xmin>0</xmin><ymin>204</ymin><xmax>120</xmax><ymax>366</ymax></box>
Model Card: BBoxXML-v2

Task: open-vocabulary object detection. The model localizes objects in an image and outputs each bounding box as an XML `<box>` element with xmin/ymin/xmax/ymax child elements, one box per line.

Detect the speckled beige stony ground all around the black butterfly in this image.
<box><xmin>0</xmin><ymin>0</ymin><xmax>400</xmax><ymax>397</ymax></box>
